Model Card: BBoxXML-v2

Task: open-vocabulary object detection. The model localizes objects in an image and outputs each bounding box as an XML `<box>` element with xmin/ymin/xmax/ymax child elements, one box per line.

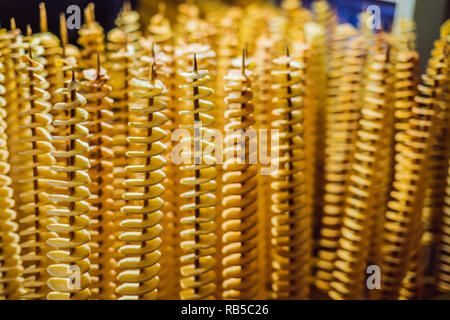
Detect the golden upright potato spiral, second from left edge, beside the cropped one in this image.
<box><xmin>15</xmin><ymin>48</ymin><xmax>55</xmax><ymax>299</ymax></box>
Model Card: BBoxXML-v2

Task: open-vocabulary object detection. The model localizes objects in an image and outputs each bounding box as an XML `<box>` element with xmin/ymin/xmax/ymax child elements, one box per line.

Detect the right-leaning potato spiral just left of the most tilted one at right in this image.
<box><xmin>329</xmin><ymin>40</ymin><xmax>392</xmax><ymax>299</ymax></box>
